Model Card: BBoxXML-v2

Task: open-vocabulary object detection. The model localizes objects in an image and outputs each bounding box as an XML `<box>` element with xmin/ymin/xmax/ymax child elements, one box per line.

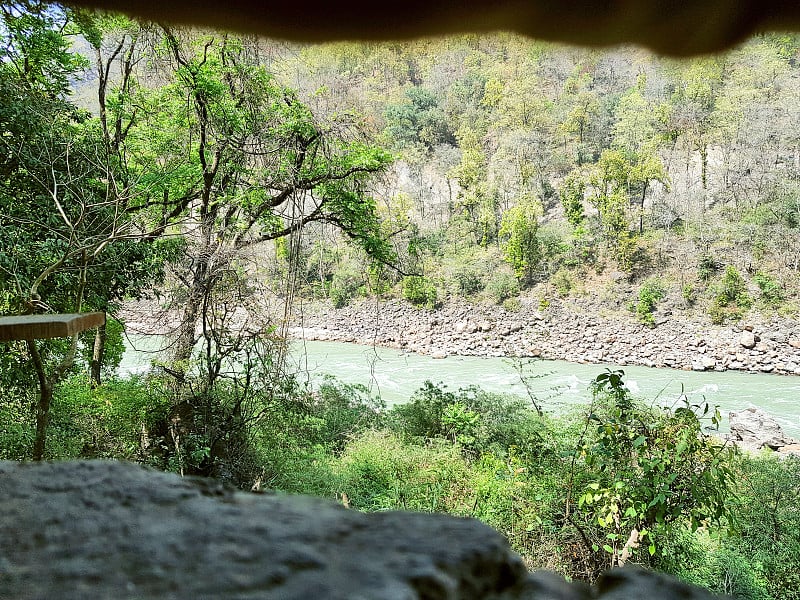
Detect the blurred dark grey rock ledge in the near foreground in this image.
<box><xmin>0</xmin><ymin>461</ymin><xmax>724</xmax><ymax>600</ymax></box>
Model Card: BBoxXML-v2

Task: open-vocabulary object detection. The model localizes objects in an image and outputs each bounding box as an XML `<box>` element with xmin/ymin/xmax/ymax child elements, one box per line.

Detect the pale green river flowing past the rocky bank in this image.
<box><xmin>120</xmin><ymin>336</ymin><xmax>800</xmax><ymax>438</ymax></box>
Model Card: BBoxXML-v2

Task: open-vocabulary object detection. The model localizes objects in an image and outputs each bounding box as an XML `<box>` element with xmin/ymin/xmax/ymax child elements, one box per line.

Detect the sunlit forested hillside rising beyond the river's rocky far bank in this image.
<box><xmin>258</xmin><ymin>35</ymin><xmax>800</xmax><ymax>322</ymax></box>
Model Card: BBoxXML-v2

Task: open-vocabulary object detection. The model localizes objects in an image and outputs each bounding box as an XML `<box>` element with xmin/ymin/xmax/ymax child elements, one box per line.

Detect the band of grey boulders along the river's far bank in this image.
<box><xmin>290</xmin><ymin>298</ymin><xmax>800</xmax><ymax>375</ymax></box>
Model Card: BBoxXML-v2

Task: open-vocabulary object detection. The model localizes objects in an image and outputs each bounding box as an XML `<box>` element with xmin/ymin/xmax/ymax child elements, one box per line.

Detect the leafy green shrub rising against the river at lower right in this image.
<box><xmin>578</xmin><ymin>371</ymin><xmax>735</xmax><ymax>565</ymax></box>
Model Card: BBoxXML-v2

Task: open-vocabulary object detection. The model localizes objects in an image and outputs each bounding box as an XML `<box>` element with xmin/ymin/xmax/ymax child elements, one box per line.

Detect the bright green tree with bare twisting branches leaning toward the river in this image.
<box><xmin>141</xmin><ymin>28</ymin><xmax>391</xmax><ymax>371</ymax></box>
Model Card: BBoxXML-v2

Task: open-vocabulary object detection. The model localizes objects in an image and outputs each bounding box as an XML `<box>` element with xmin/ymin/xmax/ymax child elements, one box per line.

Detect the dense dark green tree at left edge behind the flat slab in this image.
<box><xmin>0</xmin><ymin>2</ymin><xmax>174</xmax><ymax>459</ymax></box>
